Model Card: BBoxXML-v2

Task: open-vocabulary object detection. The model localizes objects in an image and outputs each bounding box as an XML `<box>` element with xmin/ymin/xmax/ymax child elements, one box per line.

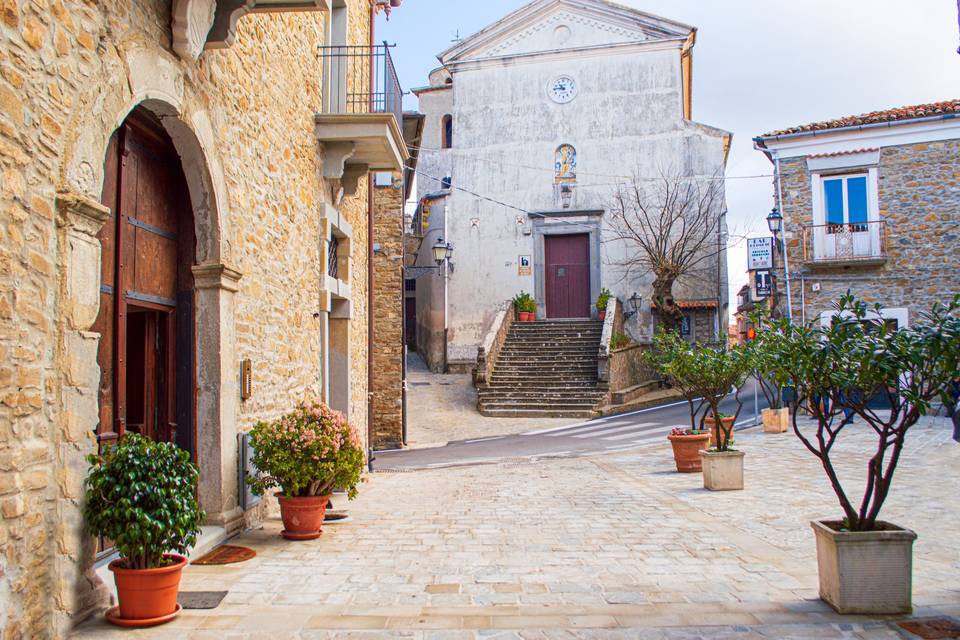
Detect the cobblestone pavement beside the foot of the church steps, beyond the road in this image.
<box><xmin>407</xmin><ymin>353</ymin><xmax>583</xmax><ymax>448</ymax></box>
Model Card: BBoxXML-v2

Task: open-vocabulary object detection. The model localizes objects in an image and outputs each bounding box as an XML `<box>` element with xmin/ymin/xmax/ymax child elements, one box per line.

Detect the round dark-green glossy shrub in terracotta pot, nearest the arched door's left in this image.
<box><xmin>83</xmin><ymin>433</ymin><xmax>205</xmax><ymax>627</ymax></box>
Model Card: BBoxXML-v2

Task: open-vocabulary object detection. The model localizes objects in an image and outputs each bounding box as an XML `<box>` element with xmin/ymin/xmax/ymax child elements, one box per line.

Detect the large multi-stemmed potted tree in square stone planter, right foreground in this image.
<box><xmin>764</xmin><ymin>293</ymin><xmax>960</xmax><ymax>614</ymax></box>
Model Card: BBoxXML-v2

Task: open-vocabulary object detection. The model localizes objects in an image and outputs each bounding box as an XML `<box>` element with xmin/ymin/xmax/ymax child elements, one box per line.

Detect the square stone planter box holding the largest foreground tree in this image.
<box><xmin>810</xmin><ymin>520</ymin><xmax>917</xmax><ymax>615</ymax></box>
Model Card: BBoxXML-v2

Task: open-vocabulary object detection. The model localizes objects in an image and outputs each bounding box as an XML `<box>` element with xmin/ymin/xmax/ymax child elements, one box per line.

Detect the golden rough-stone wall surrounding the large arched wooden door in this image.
<box><xmin>0</xmin><ymin>0</ymin><xmax>369</xmax><ymax>638</ymax></box>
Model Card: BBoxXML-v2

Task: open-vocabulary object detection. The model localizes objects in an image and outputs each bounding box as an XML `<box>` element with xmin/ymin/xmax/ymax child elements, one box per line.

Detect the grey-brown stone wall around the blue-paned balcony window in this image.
<box><xmin>777</xmin><ymin>140</ymin><xmax>960</xmax><ymax>322</ymax></box>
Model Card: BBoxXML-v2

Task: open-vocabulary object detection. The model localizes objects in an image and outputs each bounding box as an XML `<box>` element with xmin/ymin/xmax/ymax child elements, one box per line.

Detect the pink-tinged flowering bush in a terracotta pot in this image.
<box><xmin>247</xmin><ymin>400</ymin><xmax>366</xmax><ymax>540</ymax></box>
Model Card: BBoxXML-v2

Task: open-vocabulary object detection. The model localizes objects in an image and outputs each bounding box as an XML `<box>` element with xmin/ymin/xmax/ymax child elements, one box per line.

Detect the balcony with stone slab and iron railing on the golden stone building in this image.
<box><xmin>314</xmin><ymin>43</ymin><xmax>409</xmax><ymax>195</ymax></box>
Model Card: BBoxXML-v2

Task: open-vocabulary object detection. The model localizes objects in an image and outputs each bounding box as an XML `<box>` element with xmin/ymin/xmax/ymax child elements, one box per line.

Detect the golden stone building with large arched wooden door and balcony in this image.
<box><xmin>0</xmin><ymin>0</ymin><xmax>408</xmax><ymax>638</ymax></box>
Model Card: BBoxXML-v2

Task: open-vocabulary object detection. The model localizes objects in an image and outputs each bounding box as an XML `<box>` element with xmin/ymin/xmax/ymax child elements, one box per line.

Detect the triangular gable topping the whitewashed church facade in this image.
<box><xmin>438</xmin><ymin>0</ymin><xmax>695</xmax><ymax>64</ymax></box>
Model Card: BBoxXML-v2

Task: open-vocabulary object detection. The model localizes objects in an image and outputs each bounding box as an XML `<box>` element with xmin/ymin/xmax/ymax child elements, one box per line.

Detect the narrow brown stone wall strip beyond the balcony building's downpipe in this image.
<box><xmin>372</xmin><ymin>174</ymin><xmax>404</xmax><ymax>449</ymax></box>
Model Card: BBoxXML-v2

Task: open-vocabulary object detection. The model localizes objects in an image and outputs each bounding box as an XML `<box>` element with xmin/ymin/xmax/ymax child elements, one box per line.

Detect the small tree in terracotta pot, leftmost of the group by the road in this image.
<box><xmin>645</xmin><ymin>331</ymin><xmax>710</xmax><ymax>473</ymax></box>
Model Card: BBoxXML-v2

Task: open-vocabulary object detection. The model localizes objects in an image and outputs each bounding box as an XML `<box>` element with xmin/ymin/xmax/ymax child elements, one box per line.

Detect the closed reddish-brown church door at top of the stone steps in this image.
<box><xmin>544</xmin><ymin>233</ymin><xmax>590</xmax><ymax>318</ymax></box>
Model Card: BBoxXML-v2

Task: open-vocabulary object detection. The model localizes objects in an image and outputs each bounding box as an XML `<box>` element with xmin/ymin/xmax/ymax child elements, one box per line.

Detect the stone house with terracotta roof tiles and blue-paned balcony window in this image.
<box><xmin>756</xmin><ymin>100</ymin><xmax>960</xmax><ymax>326</ymax></box>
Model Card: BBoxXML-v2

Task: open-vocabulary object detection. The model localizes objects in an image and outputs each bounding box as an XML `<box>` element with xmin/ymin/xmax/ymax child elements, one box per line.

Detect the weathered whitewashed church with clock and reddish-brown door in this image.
<box><xmin>414</xmin><ymin>0</ymin><xmax>730</xmax><ymax>370</ymax></box>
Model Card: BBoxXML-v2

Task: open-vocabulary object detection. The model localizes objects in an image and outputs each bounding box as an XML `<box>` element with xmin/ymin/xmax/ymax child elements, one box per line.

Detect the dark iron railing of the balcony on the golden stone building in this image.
<box><xmin>320</xmin><ymin>42</ymin><xmax>403</xmax><ymax>125</ymax></box>
